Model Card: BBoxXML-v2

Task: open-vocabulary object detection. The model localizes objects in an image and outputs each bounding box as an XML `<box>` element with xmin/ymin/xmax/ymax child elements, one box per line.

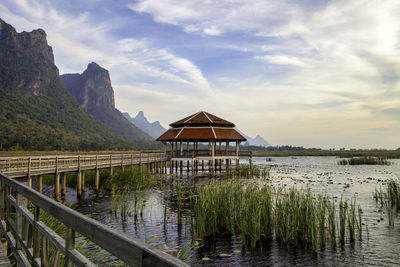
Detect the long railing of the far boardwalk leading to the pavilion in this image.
<box><xmin>0</xmin><ymin>152</ymin><xmax>166</xmax><ymax>178</ymax></box>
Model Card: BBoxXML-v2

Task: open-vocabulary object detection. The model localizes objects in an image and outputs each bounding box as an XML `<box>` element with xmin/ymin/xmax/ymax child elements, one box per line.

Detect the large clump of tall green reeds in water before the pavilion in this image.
<box><xmin>192</xmin><ymin>180</ymin><xmax>362</xmax><ymax>251</ymax></box>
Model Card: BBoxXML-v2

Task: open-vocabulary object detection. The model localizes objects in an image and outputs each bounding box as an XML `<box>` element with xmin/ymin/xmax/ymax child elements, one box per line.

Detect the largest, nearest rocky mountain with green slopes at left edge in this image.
<box><xmin>0</xmin><ymin>19</ymin><xmax>136</xmax><ymax>150</ymax></box>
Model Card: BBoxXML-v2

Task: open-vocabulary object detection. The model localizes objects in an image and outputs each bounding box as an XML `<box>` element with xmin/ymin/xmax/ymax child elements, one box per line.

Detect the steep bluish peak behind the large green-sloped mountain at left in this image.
<box><xmin>60</xmin><ymin>62</ymin><xmax>158</xmax><ymax>147</ymax></box>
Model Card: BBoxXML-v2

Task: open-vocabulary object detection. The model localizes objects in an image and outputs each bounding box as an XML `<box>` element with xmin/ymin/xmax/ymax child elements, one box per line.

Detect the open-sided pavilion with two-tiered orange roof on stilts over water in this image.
<box><xmin>157</xmin><ymin>111</ymin><xmax>251</xmax><ymax>174</ymax></box>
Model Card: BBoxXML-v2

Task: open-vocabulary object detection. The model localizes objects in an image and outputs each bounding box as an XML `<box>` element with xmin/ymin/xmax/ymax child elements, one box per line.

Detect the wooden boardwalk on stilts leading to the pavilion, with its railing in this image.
<box><xmin>0</xmin><ymin>151</ymin><xmax>169</xmax><ymax>200</ymax></box>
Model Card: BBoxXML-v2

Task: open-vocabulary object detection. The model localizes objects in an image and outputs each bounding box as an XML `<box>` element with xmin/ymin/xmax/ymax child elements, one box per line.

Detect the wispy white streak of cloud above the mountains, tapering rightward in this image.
<box><xmin>0</xmin><ymin>0</ymin><xmax>212</xmax><ymax>94</ymax></box>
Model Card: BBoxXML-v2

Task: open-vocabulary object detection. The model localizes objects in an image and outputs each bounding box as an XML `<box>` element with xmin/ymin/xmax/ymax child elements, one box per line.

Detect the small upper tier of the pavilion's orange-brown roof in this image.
<box><xmin>170</xmin><ymin>111</ymin><xmax>235</xmax><ymax>128</ymax></box>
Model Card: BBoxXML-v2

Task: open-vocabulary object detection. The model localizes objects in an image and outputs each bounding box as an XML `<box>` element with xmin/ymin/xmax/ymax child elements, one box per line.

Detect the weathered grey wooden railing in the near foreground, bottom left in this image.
<box><xmin>0</xmin><ymin>173</ymin><xmax>188</xmax><ymax>267</ymax></box>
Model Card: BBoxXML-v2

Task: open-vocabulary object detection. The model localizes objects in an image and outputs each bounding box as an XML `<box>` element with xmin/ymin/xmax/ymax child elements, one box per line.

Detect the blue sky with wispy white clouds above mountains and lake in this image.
<box><xmin>0</xmin><ymin>0</ymin><xmax>400</xmax><ymax>149</ymax></box>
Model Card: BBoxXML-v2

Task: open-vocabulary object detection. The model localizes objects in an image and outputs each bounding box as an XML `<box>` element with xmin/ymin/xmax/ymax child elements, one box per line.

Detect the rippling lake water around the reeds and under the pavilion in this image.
<box><xmin>44</xmin><ymin>157</ymin><xmax>400</xmax><ymax>266</ymax></box>
